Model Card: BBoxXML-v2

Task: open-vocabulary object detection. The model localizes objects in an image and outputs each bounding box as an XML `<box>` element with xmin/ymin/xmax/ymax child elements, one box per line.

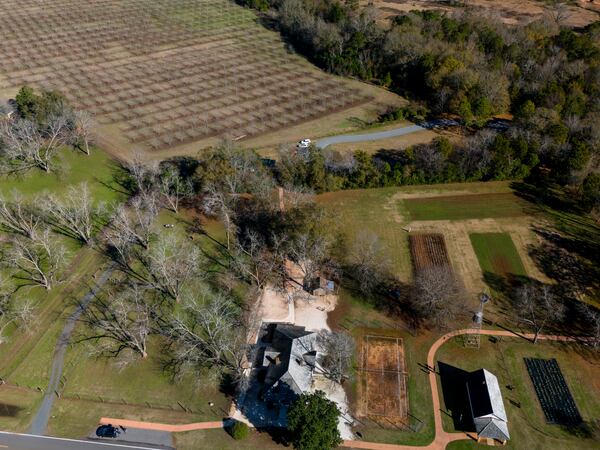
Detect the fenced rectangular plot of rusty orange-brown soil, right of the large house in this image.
<box><xmin>360</xmin><ymin>335</ymin><xmax>408</xmax><ymax>427</ymax></box>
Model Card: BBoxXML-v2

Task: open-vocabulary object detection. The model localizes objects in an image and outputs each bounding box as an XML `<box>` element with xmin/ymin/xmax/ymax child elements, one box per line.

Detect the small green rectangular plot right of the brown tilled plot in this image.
<box><xmin>469</xmin><ymin>233</ymin><xmax>527</xmax><ymax>276</ymax></box>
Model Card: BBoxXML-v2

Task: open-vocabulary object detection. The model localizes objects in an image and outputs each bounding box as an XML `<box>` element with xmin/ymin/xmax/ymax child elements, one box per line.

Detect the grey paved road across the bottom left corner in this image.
<box><xmin>0</xmin><ymin>431</ymin><xmax>156</xmax><ymax>450</ymax></box>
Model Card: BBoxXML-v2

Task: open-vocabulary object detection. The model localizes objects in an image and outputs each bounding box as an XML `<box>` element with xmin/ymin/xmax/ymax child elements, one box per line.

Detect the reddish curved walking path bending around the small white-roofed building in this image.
<box><xmin>342</xmin><ymin>329</ymin><xmax>576</xmax><ymax>450</ymax></box>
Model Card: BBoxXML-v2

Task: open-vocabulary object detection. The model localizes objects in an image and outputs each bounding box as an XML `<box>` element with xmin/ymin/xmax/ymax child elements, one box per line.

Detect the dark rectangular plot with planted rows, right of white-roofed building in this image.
<box><xmin>523</xmin><ymin>358</ymin><xmax>582</xmax><ymax>425</ymax></box>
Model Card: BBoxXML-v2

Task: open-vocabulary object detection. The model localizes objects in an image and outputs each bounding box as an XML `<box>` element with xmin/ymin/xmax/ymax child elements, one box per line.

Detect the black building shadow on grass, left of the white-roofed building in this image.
<box><xmin>438</xmin><ymin>361</ymin><xmax>475</xmax><ymax>431</ymax></box>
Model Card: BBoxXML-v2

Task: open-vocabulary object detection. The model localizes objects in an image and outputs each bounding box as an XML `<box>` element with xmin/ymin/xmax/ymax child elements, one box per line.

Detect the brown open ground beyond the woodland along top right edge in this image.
<box><xmin>361</xmin><ymin>0</ymin><xmax>600</xmax><ymax>27</ymax></box>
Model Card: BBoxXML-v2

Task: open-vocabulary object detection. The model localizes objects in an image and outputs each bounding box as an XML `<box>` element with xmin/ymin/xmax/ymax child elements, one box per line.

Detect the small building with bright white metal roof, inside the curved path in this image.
<box><xmin>467</xmin><ymin>369</ymin><xmax>510</xmax><ymax>444</ymax></box>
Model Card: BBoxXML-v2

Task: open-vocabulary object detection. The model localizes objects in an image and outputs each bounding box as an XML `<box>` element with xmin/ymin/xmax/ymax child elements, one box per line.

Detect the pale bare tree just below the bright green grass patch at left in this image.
<box><xmin>42</xmin><ymin>182</ymin><xmax>105</xmax><ymax>244</ymax></box>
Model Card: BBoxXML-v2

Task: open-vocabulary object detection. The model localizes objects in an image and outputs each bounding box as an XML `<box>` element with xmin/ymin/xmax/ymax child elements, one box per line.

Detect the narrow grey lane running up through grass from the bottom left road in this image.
<box><xmin>28</xmin><ymin>268</ymin><xmax>113</xmax><ymax>435</ymax></box>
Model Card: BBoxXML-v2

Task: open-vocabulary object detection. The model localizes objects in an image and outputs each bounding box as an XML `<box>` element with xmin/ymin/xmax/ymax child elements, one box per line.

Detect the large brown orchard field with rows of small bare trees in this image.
<box><xmin>0</xmin><ymin>0</ymin><xmax>366</xmax><ymax>156</ymax></box>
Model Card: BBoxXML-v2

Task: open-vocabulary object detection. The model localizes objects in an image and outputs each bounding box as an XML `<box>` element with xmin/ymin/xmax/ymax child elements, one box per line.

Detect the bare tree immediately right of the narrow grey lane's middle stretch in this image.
<box><xmin>80</xmin><ymin>285</ymin><xmax>156</xmax><ymax>358</ymax></box>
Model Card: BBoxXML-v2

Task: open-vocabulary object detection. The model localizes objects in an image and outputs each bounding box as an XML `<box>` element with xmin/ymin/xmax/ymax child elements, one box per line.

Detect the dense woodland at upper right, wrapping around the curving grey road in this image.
<box><xmin>236</xmin><ymin>0</ymin><xmax>600</xmax><ymax>210</ymax></box>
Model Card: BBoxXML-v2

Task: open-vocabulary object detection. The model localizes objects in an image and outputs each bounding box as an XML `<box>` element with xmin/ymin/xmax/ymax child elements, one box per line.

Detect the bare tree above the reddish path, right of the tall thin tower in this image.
<box><xmin>515</xmin><ymin>283</ymin><xmax>565</xmax><ymax>344</ymax></box>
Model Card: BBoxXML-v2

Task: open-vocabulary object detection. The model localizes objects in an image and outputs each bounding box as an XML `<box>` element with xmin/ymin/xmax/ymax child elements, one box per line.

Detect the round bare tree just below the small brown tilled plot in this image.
<box><xmin>411</xmin><ymin>266</ymin><xmax>466</xmax><ymax>329</ymax></box>
